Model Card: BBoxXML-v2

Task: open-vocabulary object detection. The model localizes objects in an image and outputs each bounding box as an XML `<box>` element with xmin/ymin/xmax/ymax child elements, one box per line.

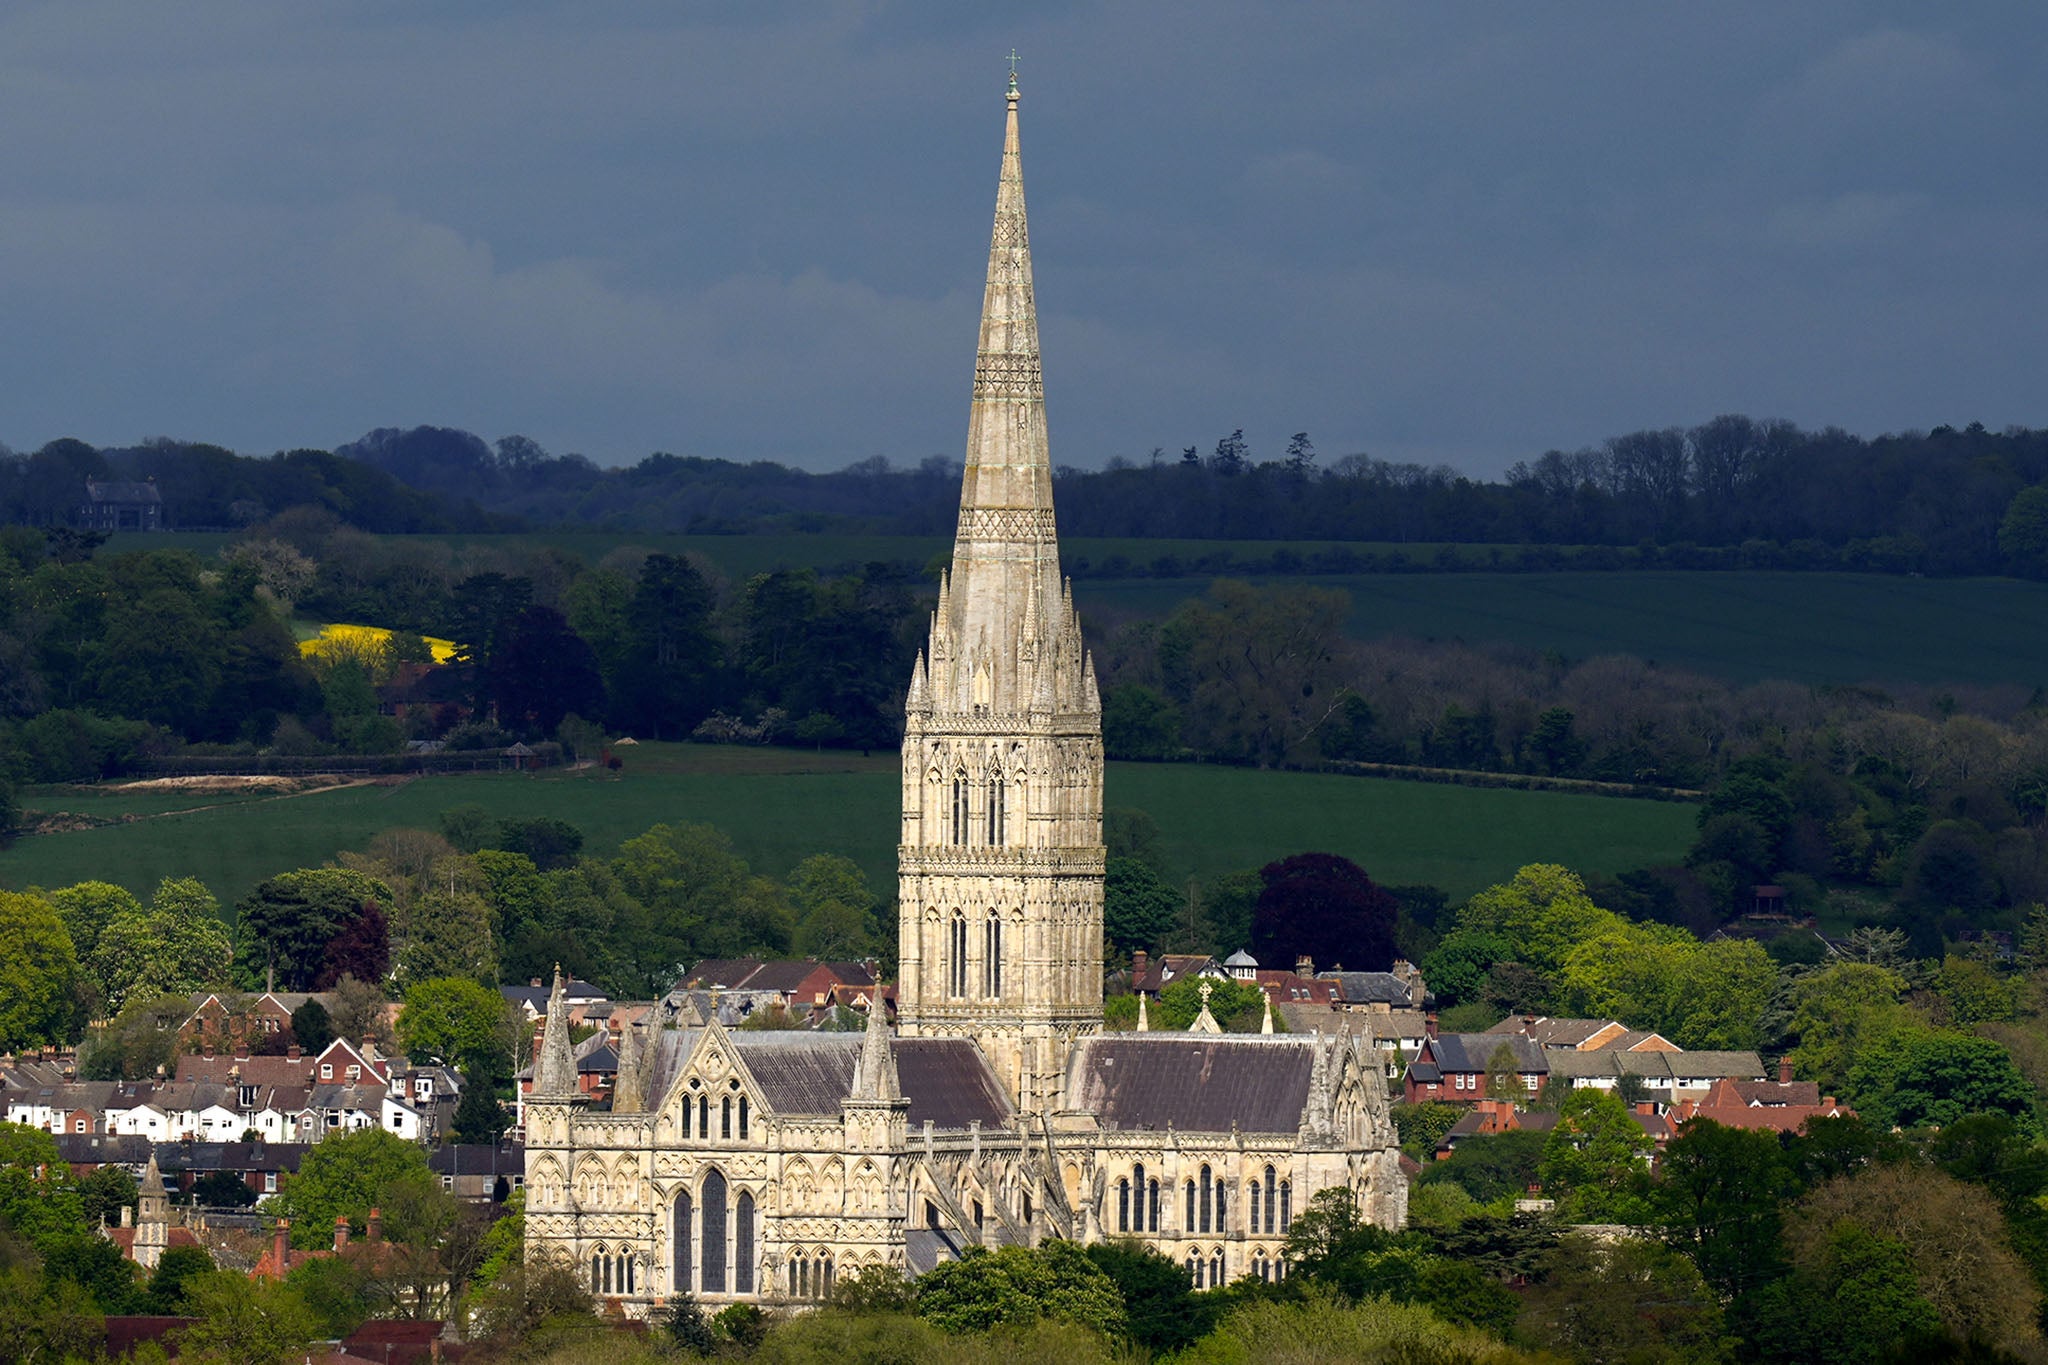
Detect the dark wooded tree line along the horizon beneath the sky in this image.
<box><xmin>12</xmin><ymin>413</ymin><xmax>2048</xmax><ymax>575</ymax></box>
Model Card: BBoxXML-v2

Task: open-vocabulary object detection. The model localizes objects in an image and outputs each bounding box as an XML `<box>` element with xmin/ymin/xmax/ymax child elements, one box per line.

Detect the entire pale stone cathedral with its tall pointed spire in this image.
<box><xmin>526</xmin><ymin>76</ymin><xmax>1407</xmax><ymax>1316</ymax></box>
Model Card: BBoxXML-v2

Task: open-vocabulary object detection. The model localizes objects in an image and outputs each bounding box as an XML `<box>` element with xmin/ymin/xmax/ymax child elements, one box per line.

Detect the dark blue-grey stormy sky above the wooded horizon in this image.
<box><xmin>0</xmin><ymin>0</ymin><xmax>2048</xmax><ymax>475</ymax></box>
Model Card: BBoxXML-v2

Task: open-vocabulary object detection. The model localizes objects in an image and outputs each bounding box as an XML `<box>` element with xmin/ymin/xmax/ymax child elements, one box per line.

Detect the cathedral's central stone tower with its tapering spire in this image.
<box><xmin>897</xmin><ymin>76</ymin><xmax>1102</xmax><ymax>1111</ymax></box>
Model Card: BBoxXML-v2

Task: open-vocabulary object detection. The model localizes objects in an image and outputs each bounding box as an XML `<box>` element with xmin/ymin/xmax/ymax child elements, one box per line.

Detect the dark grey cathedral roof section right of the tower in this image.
<box><xmin>1067</xmin><ymin>1033</ymin><xmax>1315</xmax><ymax>1134</ymax></box>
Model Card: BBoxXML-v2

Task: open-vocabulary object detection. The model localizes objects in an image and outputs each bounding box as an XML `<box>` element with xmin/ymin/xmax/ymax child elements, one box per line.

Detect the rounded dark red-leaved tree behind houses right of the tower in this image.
<box><xmin>1251</xmin><ymin>853</ymin><xmax>1401</xmax><ymax>972</ymax></box>
